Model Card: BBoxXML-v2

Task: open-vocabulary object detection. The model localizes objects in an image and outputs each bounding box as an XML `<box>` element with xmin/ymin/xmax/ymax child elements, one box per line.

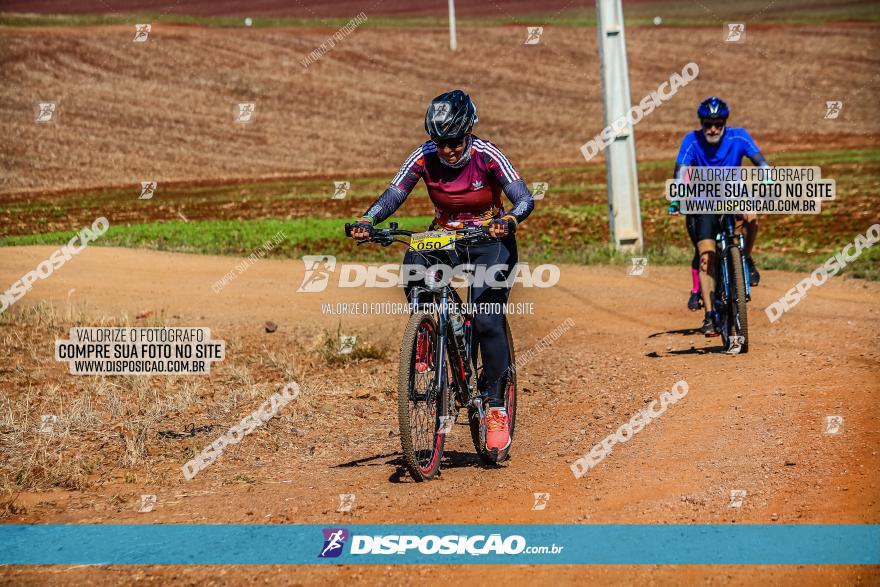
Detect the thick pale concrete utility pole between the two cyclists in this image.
<box><xmin>596</xmin><ymin>0</ymin><xmax>643</xmax><ymax>251</ymax></box>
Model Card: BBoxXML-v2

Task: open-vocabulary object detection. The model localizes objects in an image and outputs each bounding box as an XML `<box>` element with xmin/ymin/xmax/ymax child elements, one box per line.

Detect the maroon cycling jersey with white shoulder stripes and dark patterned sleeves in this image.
<box><xmin>364</xmin><ymin>135</ymin><xmax>535</xmax><ymax>230</ymax></box>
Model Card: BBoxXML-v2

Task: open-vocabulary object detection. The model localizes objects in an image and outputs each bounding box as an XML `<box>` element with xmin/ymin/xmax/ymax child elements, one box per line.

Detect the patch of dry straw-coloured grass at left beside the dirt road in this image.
<box><xmin>0</xmin><ymin>302</ymin><xmax>387</xmax><ymax>500</ymax></box>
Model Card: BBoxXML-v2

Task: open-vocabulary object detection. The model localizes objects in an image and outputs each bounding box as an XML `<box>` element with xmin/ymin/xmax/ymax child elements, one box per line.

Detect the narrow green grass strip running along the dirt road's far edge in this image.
<box><xmin>0</xmin><ymin>214</ymin><xmax>880</xmax><ymax>281</ymax></box>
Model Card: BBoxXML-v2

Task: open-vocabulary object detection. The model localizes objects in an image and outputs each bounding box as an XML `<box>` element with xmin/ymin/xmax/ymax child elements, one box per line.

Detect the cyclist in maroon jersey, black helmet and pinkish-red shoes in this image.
<box><xmin>351</xmin><ymin>90</ymin><xmax>534</xmax><ymax>460</ymax></box>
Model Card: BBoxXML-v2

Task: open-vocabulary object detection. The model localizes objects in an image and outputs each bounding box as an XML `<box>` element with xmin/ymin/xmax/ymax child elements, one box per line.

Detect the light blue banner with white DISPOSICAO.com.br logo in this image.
<box><xmin>0</xmin><ymin>524</ymin><xmax>880</xmax><ymax>565</ymax></box>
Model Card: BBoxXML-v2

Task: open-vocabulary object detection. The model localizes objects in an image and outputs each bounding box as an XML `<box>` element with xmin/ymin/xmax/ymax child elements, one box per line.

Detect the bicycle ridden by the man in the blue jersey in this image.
<box><xmin>714</xmin><ymin>214</ymin><xmax>751</xmax><ymax>354</ymax></box>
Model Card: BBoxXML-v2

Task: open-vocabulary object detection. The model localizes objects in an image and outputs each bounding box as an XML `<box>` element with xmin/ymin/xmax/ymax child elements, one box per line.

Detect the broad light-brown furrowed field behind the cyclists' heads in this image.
<box><xmin>0</xmin><ymin>23</ymin><xmax>880</xmax><ymax>193</ymax></box>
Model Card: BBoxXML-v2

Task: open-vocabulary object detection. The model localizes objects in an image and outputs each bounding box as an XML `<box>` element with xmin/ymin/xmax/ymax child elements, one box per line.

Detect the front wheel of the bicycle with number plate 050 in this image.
<box><xmin>397</xmin><ymin>312</ymin><xmax>449</xmax><ymax>481</ymax></box>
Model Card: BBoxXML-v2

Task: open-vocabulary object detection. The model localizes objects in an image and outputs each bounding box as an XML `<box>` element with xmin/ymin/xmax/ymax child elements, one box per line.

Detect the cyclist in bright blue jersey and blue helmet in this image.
<box><xmin>669</xmin><ymin>96</ymin><xmax>770</xmax><ymax>336</ymax></box>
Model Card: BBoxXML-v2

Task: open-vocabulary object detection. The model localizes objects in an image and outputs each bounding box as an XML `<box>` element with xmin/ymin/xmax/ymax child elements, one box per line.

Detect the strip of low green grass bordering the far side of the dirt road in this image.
<box><xmin>0</xmin><ymin>214</ymin><xmax>880</xmax><ymax>280</ymax></box>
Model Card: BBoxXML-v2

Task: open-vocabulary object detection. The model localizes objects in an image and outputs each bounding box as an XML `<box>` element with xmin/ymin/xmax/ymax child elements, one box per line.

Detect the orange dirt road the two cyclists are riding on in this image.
<box><xmin>0</xmin><ymin>247</ymin><xmax>880</xmax><ymax>584</ymax></box>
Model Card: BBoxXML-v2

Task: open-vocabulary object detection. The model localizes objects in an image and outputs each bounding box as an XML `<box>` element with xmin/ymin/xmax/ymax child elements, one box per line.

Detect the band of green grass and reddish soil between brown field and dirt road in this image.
<box><xmin>0</xmin><ymin>149</ymin><xmax>880</xmax><ymax>280</ymax></box>
